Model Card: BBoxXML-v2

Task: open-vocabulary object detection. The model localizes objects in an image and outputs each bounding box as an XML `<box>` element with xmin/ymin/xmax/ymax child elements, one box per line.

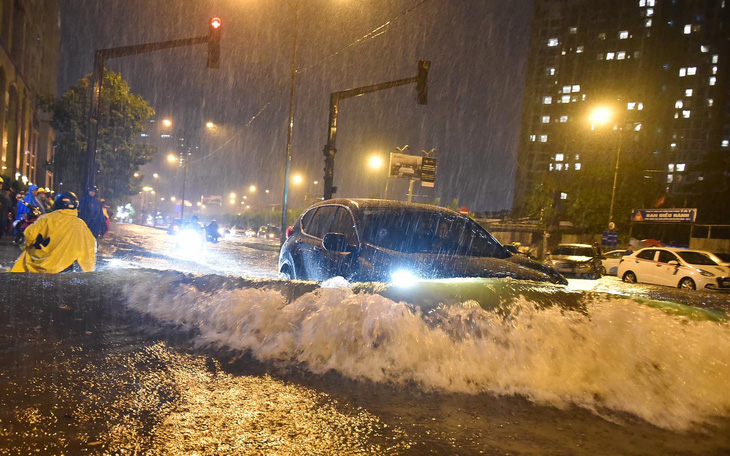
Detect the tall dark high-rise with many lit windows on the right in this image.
<box><xmin>515</xmin><ymin>0</ymin><xmax>730</xmax><ymax>216</ymax></box>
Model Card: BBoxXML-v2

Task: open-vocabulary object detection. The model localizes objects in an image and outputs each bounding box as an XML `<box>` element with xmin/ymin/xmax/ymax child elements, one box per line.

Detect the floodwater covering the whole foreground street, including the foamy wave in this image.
<box><xmin>0</xmin><ymin>269</ymin><xmax>730</xmax><ymax>455</ymax></box>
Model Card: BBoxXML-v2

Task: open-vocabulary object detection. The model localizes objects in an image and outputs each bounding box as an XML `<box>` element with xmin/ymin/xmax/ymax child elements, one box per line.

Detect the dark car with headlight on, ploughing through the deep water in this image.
<box><xmin>279</xmin><ymin>199</ymin><xmax>567</xmax><ymax>284</ymax></box>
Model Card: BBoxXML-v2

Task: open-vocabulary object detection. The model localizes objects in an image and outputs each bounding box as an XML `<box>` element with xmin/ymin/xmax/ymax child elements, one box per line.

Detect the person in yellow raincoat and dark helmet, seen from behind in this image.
<box><xmin>10</xmin><ymin>192</ymin><xmax>96</xmax><ymax>274</ymax></box>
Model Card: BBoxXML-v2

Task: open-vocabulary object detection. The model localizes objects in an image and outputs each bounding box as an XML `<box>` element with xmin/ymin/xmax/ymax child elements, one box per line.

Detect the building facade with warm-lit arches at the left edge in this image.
<box><xmin>0</xmin><ymin>0</ymin><xmax>60</xmax><ymax>187</ymax></box>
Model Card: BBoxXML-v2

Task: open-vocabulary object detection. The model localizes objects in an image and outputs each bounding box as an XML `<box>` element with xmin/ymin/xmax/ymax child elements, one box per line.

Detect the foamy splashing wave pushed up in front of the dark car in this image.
<box><xmin>125</xmin><ymin>274</ymin><xmax>730</xmax><ymax>429</ymax></box>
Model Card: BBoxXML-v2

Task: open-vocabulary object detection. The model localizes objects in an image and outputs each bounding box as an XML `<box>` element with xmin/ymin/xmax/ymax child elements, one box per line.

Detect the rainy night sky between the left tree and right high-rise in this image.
<box><xmin>59</xmin><ymin>0</ymin><xmax>532</xmax><ymax>211</ymax></box>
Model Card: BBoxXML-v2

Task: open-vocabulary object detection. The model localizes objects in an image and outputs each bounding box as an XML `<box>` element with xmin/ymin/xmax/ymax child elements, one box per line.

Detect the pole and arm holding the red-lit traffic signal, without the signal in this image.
<box><xmin>84</xmin><ymin>35</ymin><xmax>210</xmax><ymax>193</ymax></box>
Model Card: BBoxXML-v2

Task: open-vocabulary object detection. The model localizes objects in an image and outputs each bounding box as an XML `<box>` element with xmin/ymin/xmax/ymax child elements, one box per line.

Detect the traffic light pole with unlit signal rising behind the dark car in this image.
<box><xmin>323</xmin><ymin>60</ymin><xmax>430</xmax><ymax>200</ymax></box>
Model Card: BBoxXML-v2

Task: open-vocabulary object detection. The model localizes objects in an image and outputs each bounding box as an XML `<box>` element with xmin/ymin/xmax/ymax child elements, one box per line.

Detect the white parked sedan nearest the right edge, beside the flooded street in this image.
<box><xmin>618</xmin><ymin>247</ymin><xmax>730</xmax><ymax>291</ymax></box>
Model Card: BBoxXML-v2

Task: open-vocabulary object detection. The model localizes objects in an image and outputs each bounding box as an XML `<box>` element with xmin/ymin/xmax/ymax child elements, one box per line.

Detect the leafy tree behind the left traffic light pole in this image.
<box><xmin>42</xmin><ymin>71</ymin><xmax>155</xmax><ymax>200</ymax></box>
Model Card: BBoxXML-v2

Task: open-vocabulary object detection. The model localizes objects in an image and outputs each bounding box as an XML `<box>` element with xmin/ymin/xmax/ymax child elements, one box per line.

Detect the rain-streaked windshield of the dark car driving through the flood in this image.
<box><xmin>361</xmin><ymin>208</ymin><xmax>512</xmax><ymax>258</ymax></box>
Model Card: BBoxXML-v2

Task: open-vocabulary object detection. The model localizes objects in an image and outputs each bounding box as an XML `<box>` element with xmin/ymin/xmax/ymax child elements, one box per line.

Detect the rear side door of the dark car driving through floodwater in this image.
<box><xmin>296</xmin><ymin>205</ymin><xmax>337</xmax><ymax>280</ymax></box>
